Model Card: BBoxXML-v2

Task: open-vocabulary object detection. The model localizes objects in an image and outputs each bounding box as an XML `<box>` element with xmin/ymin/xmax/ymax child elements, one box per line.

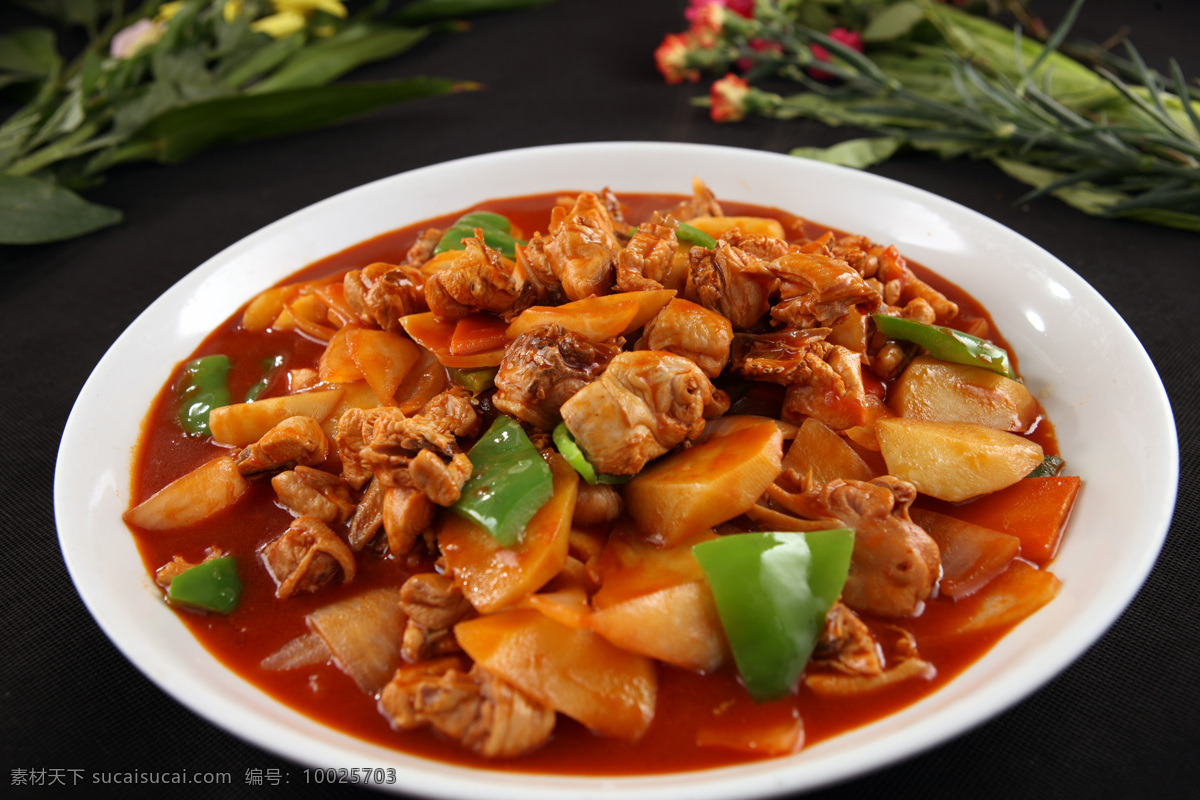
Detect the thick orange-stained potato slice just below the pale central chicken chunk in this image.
<box><xmin>624</xmin><ymin>422</ymin><xmax>784</xmax><ymax>547</ymax></box>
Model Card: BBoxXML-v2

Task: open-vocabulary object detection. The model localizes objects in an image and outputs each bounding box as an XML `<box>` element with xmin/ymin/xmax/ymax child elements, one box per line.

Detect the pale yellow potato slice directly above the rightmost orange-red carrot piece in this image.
<box><xmin>875</xmin><ymin>417</ymin><xmax>1043</xmax><ymax>503</ymax></box>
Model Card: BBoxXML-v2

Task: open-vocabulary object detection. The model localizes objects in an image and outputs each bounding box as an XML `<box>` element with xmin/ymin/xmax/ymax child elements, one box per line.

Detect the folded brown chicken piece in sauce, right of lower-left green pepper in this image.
<box><xmin>260</xmin><ymin>517</ymin><xmax>356</xmax><ymax>600</ymax></box>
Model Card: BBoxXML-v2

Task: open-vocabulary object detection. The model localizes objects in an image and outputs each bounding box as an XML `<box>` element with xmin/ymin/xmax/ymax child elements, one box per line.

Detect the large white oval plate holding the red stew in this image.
<box><xmin>54</xmin><ymin>143</ymin><xmax>1178</xmax><ymax>800</ymax></box>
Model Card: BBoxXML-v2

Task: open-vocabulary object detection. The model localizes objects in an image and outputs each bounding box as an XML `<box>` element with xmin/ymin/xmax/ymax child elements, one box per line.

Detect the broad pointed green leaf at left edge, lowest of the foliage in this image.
<box><xmin>0</xmin><ymin>174</ymin><xmax>121</xmax><ymax>245</ymax></box>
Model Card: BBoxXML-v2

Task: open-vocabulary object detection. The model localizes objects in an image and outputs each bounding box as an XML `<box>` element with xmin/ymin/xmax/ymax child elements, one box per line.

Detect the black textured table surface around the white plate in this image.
<box><xmin>0</xmin><ymin>0</ymin><xmax>1200</xmax><ymax>799</ymax></box>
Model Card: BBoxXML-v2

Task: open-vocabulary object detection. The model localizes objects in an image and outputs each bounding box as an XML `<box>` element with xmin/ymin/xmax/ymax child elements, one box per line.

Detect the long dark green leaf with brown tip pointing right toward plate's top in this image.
<box><xmin>111</xmin><ymin>78</ymin><xmax>478</xmax><ymax>167</ymax></box>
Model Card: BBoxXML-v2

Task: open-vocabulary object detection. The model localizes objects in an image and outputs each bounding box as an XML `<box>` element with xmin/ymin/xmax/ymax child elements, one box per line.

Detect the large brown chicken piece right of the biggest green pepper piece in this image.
<box><xmin>773</xmin><ymin>475</ymin><xmax>942</xmax><ymax>616</ymax></box>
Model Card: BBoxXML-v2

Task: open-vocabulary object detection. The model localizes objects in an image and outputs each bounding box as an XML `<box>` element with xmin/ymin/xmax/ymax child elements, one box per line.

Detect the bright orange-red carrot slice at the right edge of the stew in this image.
<box><xmin>938</xmin><ymin>475</ymin><xmax>1082</xmax><ymax>565</ymax></box>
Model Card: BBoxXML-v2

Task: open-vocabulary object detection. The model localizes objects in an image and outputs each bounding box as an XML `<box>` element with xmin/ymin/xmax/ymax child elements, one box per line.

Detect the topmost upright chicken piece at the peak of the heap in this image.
<box><xmin>542</xmin><ymin>192</ymin><xmax>620</xmax><ymax>300</ymax></box>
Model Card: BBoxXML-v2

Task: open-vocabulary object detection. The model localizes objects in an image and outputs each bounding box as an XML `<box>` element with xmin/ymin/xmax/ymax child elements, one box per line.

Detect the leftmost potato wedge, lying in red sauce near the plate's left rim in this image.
<box><xmin>125</xmin><ymin>456</ymin><xmax>250</xmax><ymax>530</ymax></box>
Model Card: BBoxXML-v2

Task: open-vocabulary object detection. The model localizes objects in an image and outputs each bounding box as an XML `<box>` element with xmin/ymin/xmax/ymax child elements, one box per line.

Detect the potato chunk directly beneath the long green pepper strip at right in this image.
<box><xmin>888</xmin><ymin>356</ymin><xmax>1042</xmax><ymax>433</ymax></box>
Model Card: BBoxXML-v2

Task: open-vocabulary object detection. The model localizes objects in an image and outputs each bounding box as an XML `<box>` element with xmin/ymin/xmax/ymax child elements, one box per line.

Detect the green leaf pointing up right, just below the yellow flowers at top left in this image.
<box><xmin>250</xmin><ymin>28</ymin><xmax>430</xmax><ymax>94</ymax></box>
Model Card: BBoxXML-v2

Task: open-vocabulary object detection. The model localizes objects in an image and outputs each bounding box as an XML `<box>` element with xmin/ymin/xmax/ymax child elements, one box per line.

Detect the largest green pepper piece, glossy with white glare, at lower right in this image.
<box><xmin>691</xmin><ymin>528</ymin><xmax>854</xmax><ymax>703</ymax></box>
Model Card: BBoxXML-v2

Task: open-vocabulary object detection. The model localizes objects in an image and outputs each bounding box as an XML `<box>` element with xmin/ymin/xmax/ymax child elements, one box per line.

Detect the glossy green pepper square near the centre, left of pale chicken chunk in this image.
<box><xmin>450</xmin><ymin>414</ymin><xmax>554</xmax><ymax>547</ymax></box>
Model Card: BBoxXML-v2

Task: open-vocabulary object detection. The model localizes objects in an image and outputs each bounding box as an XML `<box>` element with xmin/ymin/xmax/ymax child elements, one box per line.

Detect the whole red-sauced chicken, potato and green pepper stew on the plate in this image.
<box><xmin>126</xmin><ymin>180</ymin><xmax>1080</xmax><ymax>771</ymax></box>
